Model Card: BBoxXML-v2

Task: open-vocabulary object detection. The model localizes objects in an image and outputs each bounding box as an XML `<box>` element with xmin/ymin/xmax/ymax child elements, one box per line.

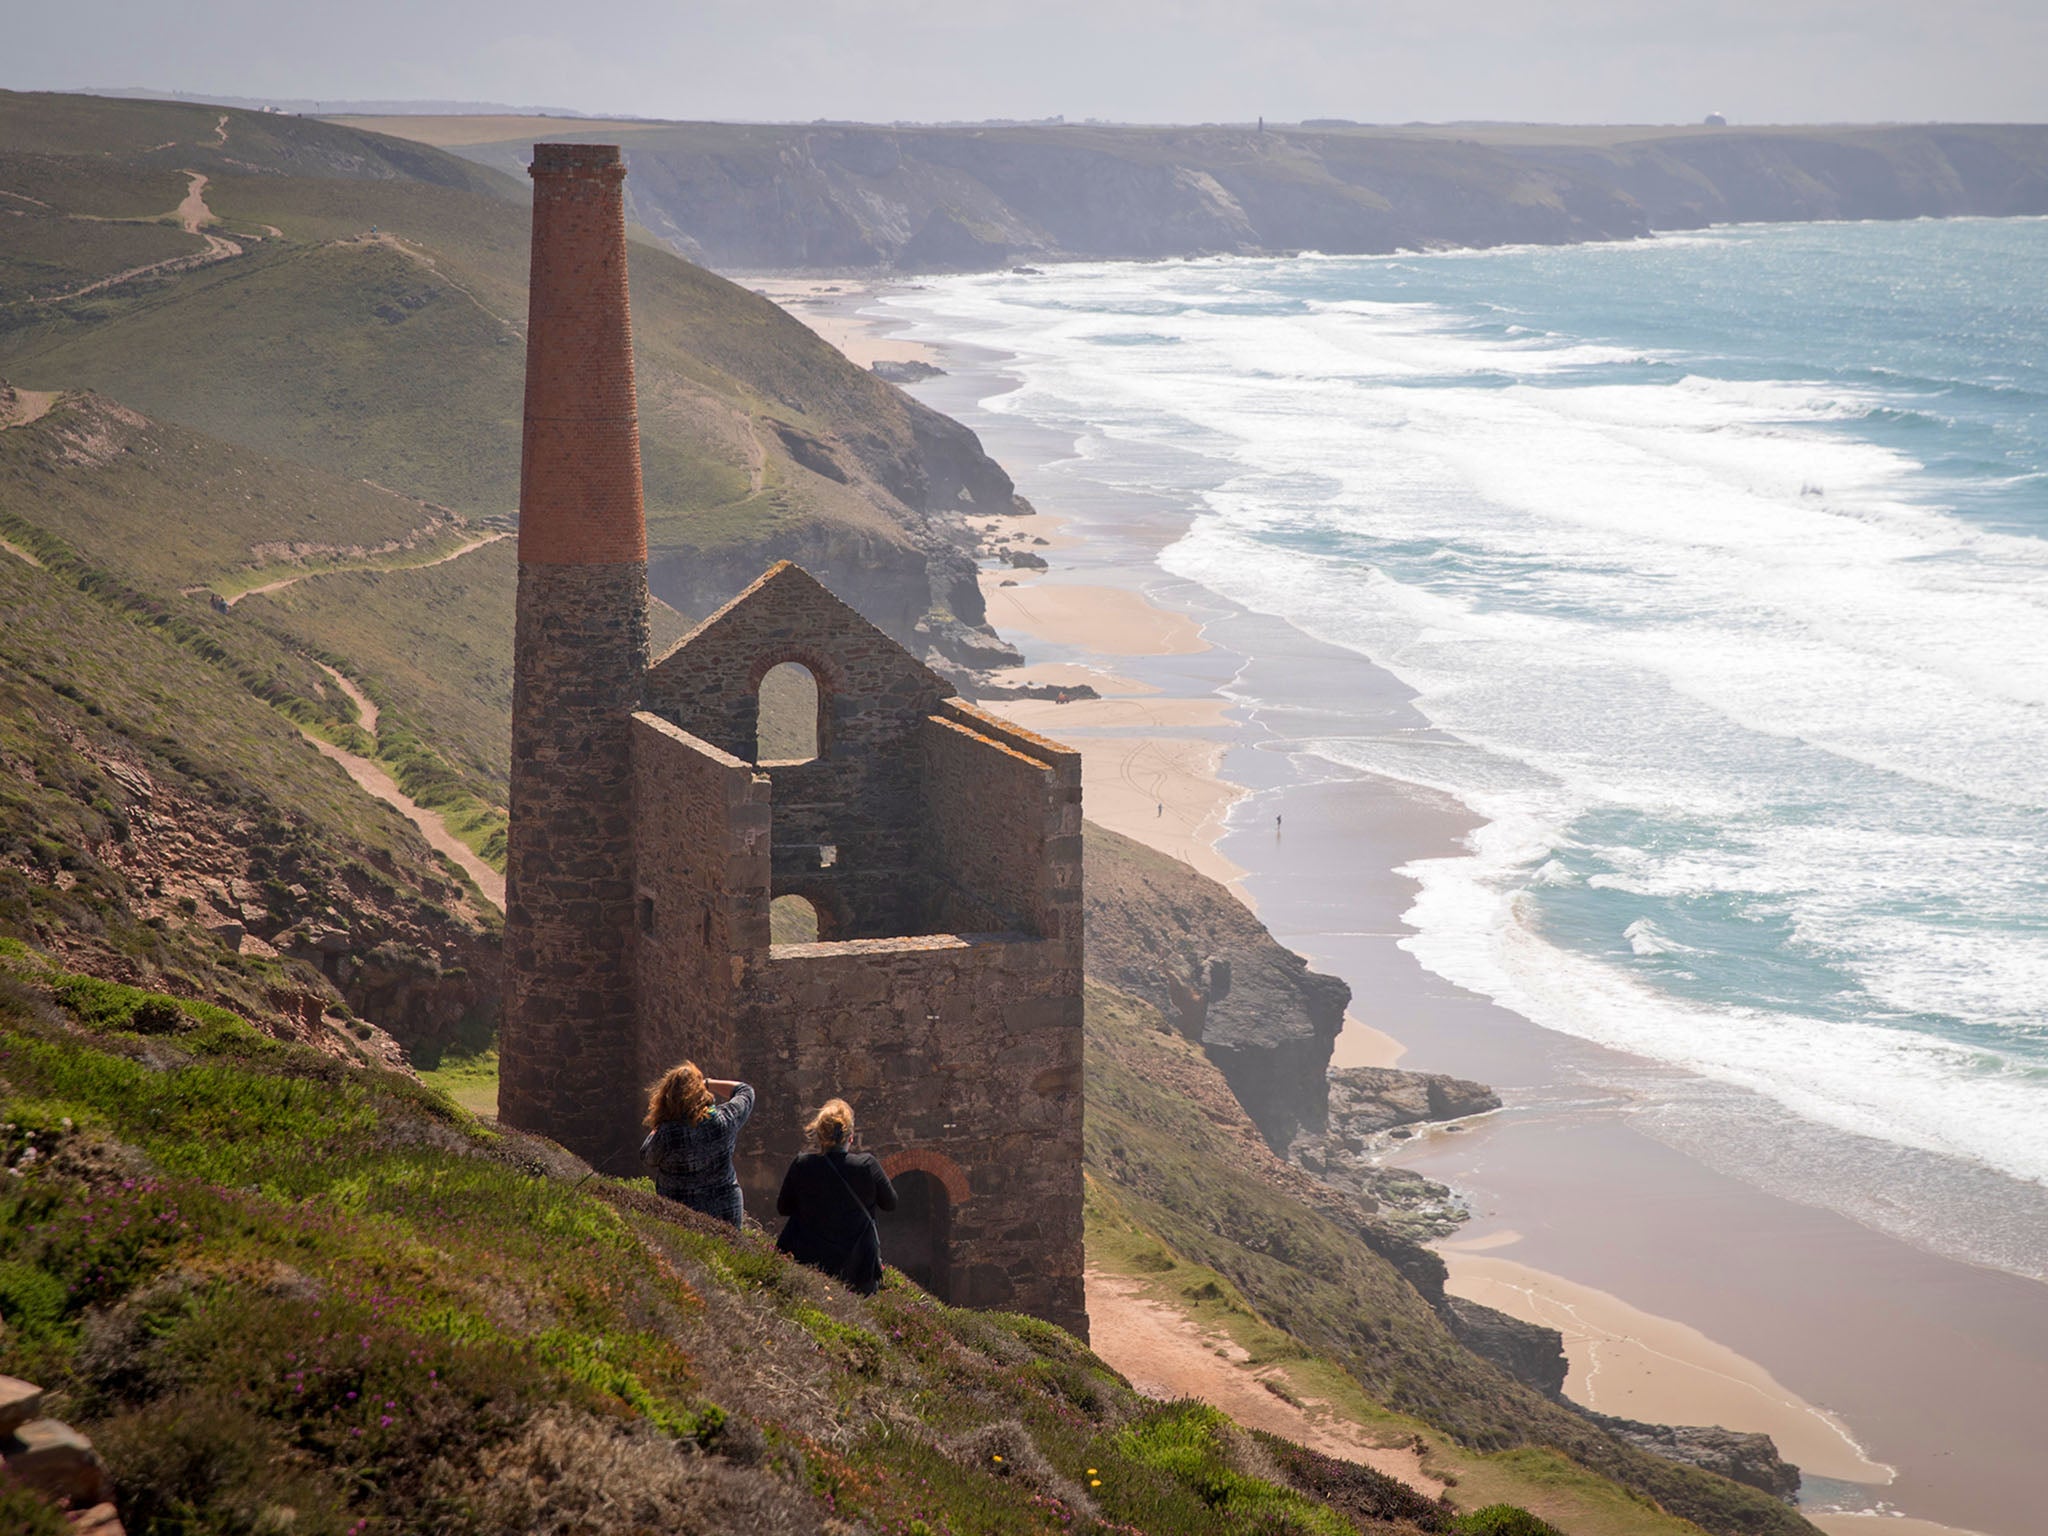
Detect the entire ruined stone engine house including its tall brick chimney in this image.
<box><xmin>500</xmin><ymin>143</ymin><xmax>1087</xmax><ymax>1331</ymax></box>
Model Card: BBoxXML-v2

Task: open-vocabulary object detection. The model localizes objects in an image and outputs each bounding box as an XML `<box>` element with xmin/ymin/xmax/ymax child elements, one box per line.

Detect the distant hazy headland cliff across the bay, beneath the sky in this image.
<box><xmin>444</xmin><ymin>123</ymin><xmax>2048</xmax><ymax>272</ymax></box>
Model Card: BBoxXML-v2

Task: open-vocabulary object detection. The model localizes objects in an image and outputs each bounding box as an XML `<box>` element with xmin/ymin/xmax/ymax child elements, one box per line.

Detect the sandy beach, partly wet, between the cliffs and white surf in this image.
<box><xmin>770</xmin><ymin>285</ymin><xmax>2048</xmax><ymax>1536</ymax></box>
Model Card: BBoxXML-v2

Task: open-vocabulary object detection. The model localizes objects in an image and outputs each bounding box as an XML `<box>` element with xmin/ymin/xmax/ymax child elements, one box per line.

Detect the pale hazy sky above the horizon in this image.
<box><xmin>0</xmin><ymin>0</ymin><xmax>2048</xmax><ymax>123</ymax></box>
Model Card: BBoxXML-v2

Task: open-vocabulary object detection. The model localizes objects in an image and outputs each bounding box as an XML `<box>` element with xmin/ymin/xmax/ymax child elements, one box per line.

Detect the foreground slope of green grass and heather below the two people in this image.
<box><xmin>0</xmin><ymin>944</ymin><xmax>1546</xmax><ymax>1536</ymax></box>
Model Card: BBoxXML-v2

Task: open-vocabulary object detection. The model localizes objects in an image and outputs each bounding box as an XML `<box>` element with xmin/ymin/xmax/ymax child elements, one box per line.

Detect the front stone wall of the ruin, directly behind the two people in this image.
<box><xmin>739</xmin><ymin>934</ymin><xmax>1087</xmax><ymax>1337</ymax></box>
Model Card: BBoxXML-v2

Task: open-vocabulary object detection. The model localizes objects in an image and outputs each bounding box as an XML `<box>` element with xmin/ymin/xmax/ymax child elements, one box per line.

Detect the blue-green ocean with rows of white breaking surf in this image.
<box><xmin>883</xmin><ymin>219</ymin><xmax>2048</xmax><ymax>1272</ymax></box>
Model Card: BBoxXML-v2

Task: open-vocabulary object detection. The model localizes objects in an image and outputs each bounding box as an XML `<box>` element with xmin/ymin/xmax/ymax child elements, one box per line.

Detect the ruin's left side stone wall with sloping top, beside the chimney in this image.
<box><xmin>633</xmin><ymin>713</ymin><xmax>768</xmax><ymax>1085</ymax></box>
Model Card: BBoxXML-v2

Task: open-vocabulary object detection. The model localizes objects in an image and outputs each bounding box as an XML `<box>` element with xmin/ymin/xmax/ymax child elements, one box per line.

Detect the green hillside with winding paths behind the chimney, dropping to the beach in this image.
<box><xmin>0</xmin><ymin>92</ymin><xmax>1012</xmax><ymax>651</ymax></box>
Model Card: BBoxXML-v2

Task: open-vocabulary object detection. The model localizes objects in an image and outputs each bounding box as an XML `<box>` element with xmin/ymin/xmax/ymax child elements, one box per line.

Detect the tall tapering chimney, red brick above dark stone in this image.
<box><xmin>498</xmin><ymin>143</ymin><xmax>647</xmax><ymax>1171</ymax></box>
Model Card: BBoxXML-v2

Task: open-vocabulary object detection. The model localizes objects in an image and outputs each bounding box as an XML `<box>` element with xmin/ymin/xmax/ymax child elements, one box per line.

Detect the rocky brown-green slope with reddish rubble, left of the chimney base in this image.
<box><xmin>0</xmin><ymin>514</ymin><xmax>498</xmax><ymax>1055</ymax></box>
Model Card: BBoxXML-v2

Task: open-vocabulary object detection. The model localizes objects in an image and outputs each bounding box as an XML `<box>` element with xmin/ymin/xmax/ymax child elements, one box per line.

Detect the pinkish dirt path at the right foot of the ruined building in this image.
<box><xmin>1087</xmin><ymin>1268</ymin><xmax>1444</xmax><ymax>1499</ymax></box>
